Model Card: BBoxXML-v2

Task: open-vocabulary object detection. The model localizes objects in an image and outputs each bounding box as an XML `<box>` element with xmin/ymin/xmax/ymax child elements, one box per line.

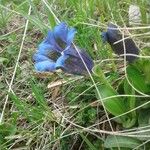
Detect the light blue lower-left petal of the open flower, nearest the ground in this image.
<box><xmin>34</xmin><ymin>60</ymin><xmax>55</xmax><ymax>72</ymax></box>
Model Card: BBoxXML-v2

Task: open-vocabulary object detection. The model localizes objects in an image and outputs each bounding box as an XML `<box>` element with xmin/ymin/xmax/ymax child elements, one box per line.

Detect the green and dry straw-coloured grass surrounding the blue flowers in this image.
<box><xmin>0</xmin><ymin>0</ymin><xmax>150</xmax><ymax>150</ymax></box>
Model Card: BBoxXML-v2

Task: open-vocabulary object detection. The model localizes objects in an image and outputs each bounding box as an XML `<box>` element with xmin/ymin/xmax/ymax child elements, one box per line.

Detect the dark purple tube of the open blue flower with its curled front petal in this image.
<box><xmin>56</xmin><ymin>47</ymin><xmax>93</xmax><ymax>75</ymax></box>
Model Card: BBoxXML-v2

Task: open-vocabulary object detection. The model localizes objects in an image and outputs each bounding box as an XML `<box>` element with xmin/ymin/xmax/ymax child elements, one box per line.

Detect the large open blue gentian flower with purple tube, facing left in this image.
<box><xmin>33</xmin><ymin>23</ymin><xmax>93</xmax><ymax>75</ymax></box>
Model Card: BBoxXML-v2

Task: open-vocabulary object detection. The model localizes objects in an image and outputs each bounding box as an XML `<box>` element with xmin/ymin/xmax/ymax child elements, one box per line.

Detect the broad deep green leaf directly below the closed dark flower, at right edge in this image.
<box><xmin>127</xmin><ymin>66</ymin><xmax>148</xmax><ymax>93</ymax></box>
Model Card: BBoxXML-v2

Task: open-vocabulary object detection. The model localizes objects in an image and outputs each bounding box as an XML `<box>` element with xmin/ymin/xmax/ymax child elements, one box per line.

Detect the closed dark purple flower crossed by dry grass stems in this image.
<box><xmin>102</xmin><ymin>23</ymin><xmax>139</xmax><ymax>62</ymax></box>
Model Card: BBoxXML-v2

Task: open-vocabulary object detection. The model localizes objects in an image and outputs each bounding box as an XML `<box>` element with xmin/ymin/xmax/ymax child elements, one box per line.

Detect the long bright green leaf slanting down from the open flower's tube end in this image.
<box><xmin>93</xmin><ymin>66</ymin><xmax>128</xmax><ymax>123</ymax></box>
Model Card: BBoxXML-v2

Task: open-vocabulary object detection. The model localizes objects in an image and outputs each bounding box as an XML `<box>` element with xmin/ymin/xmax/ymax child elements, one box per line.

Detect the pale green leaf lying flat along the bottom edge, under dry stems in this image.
<box><xmin>104</xmin><ymin>135</ymin><xmax>142</xmax><ymax>148</ymax></box>
